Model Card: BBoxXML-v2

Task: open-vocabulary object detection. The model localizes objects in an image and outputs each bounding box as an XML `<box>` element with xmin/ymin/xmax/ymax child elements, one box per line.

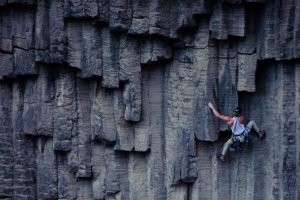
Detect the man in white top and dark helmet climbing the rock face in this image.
<box><xmin>208</xmin><ymin>102</ymin><xmax>265</xmax><ymax>161</ymax></box>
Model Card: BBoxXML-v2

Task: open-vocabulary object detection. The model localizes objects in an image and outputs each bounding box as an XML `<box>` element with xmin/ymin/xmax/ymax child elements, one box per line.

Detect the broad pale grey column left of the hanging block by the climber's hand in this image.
<box><xmin>164</xmin><ymin>49</ymin><xmax>195</xmax><ymax>199</ymax></box>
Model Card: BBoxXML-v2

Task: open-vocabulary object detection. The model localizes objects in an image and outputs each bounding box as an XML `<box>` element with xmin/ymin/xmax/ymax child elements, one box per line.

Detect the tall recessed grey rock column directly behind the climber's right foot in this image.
<box><xmin>251</xmin><ymin>60</ymin><xmax>281</xmax><ymax>199</ymax></box>
